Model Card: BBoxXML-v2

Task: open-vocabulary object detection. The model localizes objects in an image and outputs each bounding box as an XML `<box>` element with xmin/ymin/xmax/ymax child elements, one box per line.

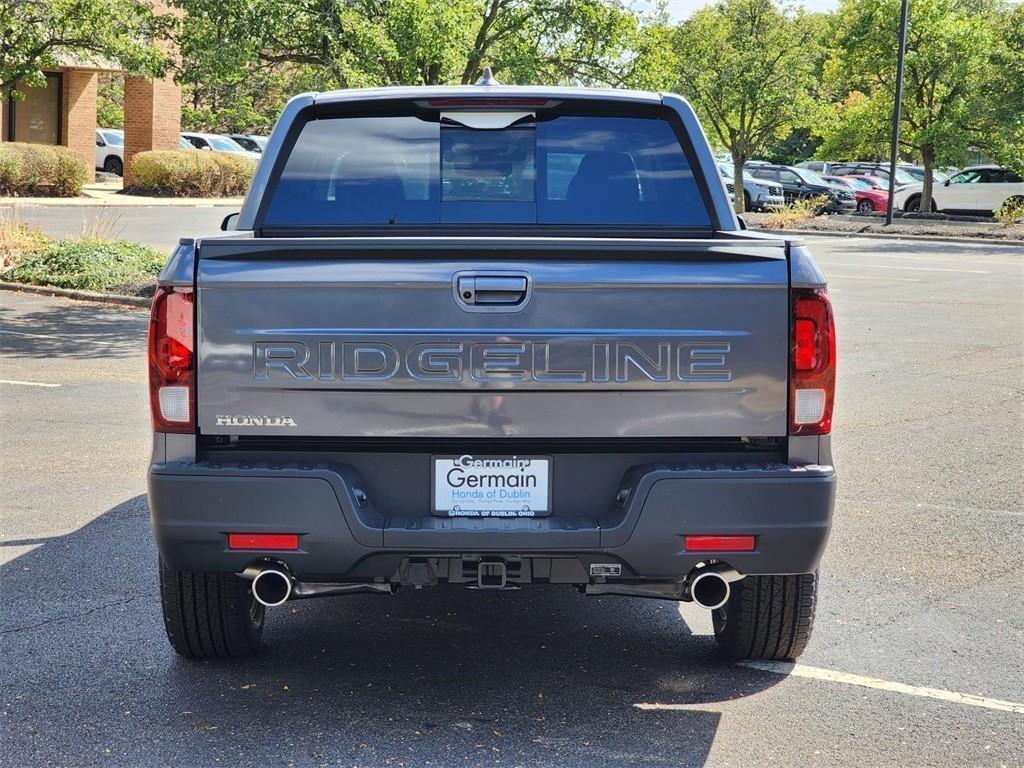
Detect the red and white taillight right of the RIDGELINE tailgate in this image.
<box><xmin>790</xmin><ymin>288</ymin><xmax>836</xmax><ymax>435</ymax></box>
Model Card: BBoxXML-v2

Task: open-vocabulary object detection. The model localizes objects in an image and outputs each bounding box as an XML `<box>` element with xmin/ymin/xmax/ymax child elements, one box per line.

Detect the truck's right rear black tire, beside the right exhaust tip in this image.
<box><xmin>712</xmin><ymin>573</ymin><xmax>817</xmax><ymax>660</ymax></box>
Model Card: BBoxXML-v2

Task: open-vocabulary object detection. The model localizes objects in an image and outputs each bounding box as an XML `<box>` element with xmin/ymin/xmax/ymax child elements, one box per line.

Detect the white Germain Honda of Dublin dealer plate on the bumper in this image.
<box><xmin>433</xmin><ymin>454</ymin><xmax>551</xmax><ymax>517</ymax></box>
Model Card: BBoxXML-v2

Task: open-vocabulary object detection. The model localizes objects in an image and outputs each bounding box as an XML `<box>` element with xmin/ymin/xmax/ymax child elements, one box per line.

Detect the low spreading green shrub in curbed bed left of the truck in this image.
<box><xmin>2</xmin><ymin>239</ymin><xmax>166</xmax><ymax>293</ymax></box>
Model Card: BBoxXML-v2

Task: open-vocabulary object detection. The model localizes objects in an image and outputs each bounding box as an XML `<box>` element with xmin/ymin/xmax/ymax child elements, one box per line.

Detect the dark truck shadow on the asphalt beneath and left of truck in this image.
<box><xmin>0</xmin><ymin>496</ymin><xmax>782</xmax><ymax>766</ymax></box>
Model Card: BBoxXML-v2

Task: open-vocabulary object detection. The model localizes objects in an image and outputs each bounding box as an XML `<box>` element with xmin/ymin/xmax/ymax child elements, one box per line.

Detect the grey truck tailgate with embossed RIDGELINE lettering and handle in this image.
<box><xmin>197</xmin><ymin>238</ymin><xmax>788</xmax><ymax>438</ymax></box>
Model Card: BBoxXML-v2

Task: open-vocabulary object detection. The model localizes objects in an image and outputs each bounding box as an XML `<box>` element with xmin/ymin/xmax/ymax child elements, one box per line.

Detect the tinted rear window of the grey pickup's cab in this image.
<box><xmin>262</xmin><ymin>113</ymin><xmax>710</xmax><ymax>228</ymax></box>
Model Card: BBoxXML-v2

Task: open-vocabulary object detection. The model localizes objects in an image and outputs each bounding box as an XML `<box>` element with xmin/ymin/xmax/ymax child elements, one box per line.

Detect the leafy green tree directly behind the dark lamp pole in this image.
<box><xmin>825</xmin><ymin>0</ymin><xmax>1000</xmax><ymax>210</ymax></box>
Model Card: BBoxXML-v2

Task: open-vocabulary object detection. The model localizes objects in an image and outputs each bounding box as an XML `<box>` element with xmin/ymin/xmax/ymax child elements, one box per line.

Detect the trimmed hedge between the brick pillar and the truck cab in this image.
<box><xmin>131</xmin><ymin>150</ymin><xmax>256</xmax><ymax>198</ymax></box>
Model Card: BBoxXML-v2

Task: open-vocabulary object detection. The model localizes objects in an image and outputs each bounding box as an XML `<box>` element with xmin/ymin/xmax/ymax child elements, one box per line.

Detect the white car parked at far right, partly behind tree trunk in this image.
<box><xmin>893</xmin><ymin>165</ymin><xmax>1024</xmax><ymax>216</ymax></box>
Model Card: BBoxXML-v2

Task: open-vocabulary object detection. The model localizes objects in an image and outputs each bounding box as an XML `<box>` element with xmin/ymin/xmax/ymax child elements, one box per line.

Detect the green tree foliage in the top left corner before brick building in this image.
<box><xmin>0</xmin><ymin>0</ymin><xmax>176</xmax><ymax>98</ymax></box>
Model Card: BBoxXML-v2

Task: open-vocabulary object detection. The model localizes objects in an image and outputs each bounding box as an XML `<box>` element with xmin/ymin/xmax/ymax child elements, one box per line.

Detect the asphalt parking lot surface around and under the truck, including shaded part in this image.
<box><xmin>0</xmin><ymin>238</ymin><xmax>1024</xmax><ymax>768</ymax></box>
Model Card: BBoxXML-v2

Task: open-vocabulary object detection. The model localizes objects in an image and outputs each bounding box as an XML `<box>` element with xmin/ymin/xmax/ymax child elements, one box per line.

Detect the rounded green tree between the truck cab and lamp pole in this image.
<box><xmin>674</xmin><ymin>0</ymin><xmax>822</xmax><ymax>213</ymax></box>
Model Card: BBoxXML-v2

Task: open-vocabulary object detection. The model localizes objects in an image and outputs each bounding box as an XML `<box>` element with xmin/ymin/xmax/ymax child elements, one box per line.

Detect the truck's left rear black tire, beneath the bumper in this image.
<box><xmin>160</xmin><ymin>560</ymin><xmax>265</xmax><ymax>658</ymax></box>
